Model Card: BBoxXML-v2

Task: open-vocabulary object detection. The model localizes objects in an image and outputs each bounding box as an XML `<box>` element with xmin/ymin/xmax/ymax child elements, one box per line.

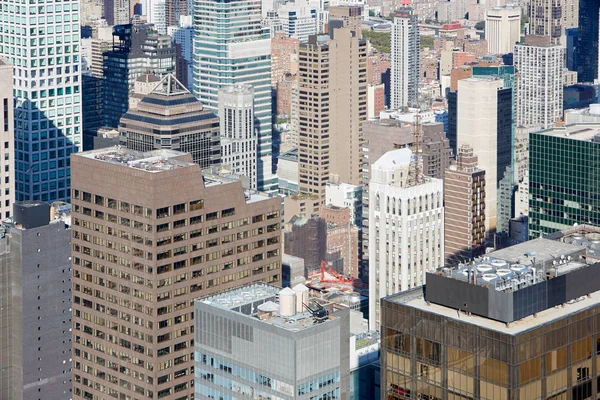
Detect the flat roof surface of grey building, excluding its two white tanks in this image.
<box><xmin>197</xmin><ymin>283</ymin><xmax>337</xmax><ymax>331</ymax></box>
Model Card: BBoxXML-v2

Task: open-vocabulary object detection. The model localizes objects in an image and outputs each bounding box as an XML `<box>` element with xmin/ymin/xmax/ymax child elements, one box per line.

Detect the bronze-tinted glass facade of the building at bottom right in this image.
<box><xmin>381</xmin><ymin>289</ymin><xmax>600</xmax><ymax>400</ymax></box>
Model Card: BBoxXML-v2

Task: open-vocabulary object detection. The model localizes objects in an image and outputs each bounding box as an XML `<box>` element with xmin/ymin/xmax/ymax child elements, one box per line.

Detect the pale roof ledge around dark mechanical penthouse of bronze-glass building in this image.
<box><xmin>386</xmin><ymin>287</ymin><xmax>600</xmax><ymax>335</ymax></box>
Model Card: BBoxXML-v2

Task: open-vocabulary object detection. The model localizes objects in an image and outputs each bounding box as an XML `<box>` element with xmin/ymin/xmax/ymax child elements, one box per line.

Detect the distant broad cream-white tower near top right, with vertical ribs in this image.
<box><xmin>485</xmin><ymin>5</ymin><xmax>521</xmax><ymax>54</ymax></box>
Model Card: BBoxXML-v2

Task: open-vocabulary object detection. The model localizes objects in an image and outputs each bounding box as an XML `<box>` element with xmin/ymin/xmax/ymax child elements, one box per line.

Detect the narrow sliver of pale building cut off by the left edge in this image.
<box><xmin>0</xmin><ymin>59</ymin><xmax>15</xmax><ymax>219</ymax></box>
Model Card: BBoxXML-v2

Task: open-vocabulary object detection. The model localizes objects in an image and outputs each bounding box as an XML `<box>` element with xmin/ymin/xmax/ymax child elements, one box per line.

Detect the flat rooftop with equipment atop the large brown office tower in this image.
<box><xmin>78</xmin><ymin>146</ymin><xmax>196</xmax><ymax>173</ymax></box>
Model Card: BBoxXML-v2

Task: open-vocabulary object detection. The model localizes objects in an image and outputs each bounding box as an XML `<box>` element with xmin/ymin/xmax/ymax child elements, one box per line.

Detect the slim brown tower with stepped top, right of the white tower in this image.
<box><xmin>444</xmin><ymin>144</ymin><xmax>485</xmax><ymax>265</ymax></box>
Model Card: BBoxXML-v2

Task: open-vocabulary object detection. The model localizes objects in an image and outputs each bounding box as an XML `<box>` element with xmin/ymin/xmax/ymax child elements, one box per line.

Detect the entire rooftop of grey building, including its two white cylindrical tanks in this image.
<box><xmin>197</xmin><ymin>283</ymin><xmax>337</xmax><ymax>332</ymax></box>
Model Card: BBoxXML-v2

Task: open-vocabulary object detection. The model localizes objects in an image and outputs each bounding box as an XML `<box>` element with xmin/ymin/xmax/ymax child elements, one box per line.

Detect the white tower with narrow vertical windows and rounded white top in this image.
<box><xmin>369</xmin><ymin>149</ymin><xmax>444</xmax><ymax>330</ymax></box>
